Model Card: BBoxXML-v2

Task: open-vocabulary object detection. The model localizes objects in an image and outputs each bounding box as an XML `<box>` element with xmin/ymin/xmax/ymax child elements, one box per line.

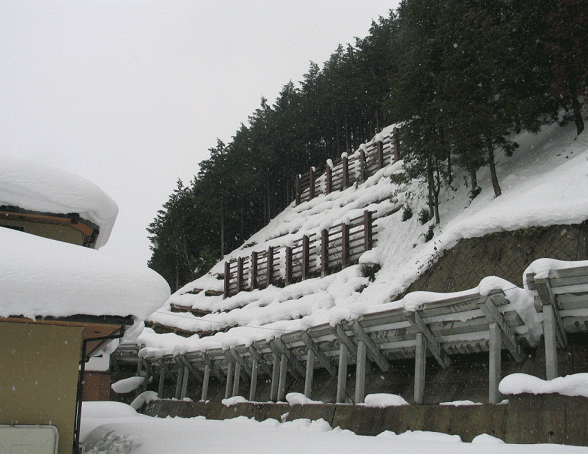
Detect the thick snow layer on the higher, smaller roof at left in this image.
<box><xmin>0</xmin><ymin>156</ymin><xmax>118</xmax><ymax>249</ymax></box>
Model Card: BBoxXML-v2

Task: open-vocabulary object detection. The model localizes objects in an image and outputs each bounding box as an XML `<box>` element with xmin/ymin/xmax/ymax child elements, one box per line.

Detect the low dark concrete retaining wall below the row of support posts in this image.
<box><xmin>144</xmin><ymin>394</ymin><xmax>588</xmax><ymax>446</ymax></box>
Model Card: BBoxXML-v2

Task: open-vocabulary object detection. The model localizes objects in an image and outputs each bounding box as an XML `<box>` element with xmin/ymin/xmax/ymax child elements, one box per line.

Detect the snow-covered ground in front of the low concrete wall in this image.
<box><xmin>82</xmin><ymin>402</ymin><xmax>588</xmax><ymax>454</ymax></box>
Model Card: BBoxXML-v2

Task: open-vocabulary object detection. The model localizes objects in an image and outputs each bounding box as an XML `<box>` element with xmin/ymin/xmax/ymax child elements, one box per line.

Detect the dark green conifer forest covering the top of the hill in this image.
<box><xmin>147</xmin><ymin>0</ymin><xmax>588</xmax><ymax>291</ymax></box>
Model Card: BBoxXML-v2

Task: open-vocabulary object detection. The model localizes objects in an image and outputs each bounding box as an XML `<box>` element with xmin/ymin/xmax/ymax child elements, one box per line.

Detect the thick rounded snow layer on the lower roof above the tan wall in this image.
<box><xmin>0</xmin><ymin>228</ymin><xmax>170</xmax><ymax>320</ymax></box>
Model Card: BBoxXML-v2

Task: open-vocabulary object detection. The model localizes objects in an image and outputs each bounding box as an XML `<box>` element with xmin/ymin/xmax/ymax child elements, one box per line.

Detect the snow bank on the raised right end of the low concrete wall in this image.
<box><xmin>498</xmin><ymin>373</ymin><xmax>588</xmax><ymax>397</ymax></box>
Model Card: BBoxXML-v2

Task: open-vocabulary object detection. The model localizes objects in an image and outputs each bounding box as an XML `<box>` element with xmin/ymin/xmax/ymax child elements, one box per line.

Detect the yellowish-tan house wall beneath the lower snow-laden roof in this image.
<box><xmin>0</xmin><ymin>322</ymin><xmax>83</xmax><ymax>454</ymax></box>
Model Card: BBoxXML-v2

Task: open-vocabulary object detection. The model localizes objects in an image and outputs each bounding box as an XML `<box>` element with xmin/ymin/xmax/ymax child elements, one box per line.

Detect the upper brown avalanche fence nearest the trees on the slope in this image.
<box><xmin>296</xmin><ymin>128</ymin><xmax>400</xmax><ymax>205</ymax></box>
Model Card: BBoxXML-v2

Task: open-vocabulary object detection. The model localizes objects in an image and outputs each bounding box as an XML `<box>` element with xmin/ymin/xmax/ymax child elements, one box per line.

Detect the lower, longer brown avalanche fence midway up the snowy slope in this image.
<box><xmin>224</xmin><ymin>211</ymin><xmax>377</xmax><ymax>298</ymax></box>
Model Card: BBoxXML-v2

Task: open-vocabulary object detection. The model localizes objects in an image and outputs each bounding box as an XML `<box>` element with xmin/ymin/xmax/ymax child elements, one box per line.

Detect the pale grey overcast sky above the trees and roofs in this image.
<box><xmin>0</xmin><ymin>0</ymin><xmax>398</xmax><ymax>264</ymax></box>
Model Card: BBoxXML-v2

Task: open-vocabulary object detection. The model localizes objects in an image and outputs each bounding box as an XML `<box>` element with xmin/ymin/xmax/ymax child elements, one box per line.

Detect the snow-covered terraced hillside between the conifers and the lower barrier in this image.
<box><xmin>141</xmin><ymin>121</ymin><xmax>588</xmax><ymax>351</ymax></box>
